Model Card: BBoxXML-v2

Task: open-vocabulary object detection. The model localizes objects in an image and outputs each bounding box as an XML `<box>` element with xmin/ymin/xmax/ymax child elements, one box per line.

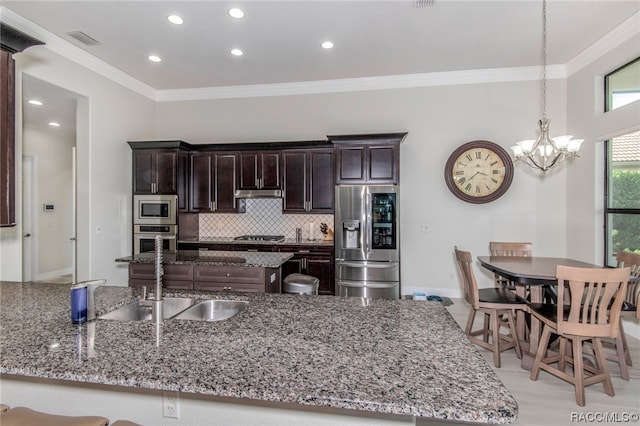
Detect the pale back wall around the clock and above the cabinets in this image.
<box><xmin>156</xmin><ymin>80</ymin><xmax>568</xmax><ymax>295</ymax></box>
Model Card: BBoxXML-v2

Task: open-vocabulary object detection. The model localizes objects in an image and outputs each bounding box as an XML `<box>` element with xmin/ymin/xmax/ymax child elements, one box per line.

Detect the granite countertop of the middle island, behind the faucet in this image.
<box><xmin>116</xmin><ymin>250</ymin><xmax>293</xmax><ymax>268</ymax></box>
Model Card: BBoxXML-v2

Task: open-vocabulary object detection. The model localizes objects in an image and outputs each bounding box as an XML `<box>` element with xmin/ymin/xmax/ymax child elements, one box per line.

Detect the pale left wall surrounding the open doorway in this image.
<box><xmin>0</xmin><ymin>46</ymin><xmax>155</xmax><ymax>285</ymax></box>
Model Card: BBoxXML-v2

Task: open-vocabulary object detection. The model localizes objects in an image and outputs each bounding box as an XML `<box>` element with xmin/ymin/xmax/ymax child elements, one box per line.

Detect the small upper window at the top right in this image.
<box><xmin>604</xmin><ymin>58</ymin><xmax>640</xmax><ymax>112</ymax></box>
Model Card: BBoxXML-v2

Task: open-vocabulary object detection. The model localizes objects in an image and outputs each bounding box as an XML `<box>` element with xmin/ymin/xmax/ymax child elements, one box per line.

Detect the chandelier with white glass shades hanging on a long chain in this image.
<box><xmin>511</xmin><ymin>0</ymin><xmax>584</xmax><ymax>173</ymax></box>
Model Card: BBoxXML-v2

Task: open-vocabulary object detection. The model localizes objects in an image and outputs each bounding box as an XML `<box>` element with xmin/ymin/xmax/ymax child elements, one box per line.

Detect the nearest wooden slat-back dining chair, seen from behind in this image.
<box><xmin>530</xmin><ymin>266</ymin><xmax>630</xmax><ymax>406</ymax></box>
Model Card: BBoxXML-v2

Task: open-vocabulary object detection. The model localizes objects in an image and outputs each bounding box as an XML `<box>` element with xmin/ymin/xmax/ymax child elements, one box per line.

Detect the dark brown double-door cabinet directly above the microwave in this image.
<box><xmin>133</xmin><ymin>149</ymin><xmax>178</xmax><ymax>194</ymax></box>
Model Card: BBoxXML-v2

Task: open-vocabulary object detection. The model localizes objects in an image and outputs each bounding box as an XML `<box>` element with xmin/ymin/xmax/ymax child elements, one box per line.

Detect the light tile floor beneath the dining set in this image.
<box><xmin>447</xmin><ymin>299</ymin><xmax>640</xmax><ymax>426</ymax></box>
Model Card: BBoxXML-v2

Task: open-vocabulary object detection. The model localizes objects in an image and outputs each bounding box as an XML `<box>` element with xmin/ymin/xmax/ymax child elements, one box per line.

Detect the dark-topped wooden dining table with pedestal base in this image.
<box><xmin>478</xmin><ymin>256</ymin><xmax>602</xmax><ymax>370</ymax></box>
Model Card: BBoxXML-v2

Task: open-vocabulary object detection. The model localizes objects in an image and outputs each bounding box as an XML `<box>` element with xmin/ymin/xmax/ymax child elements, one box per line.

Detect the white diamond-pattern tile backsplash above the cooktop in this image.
<box><xmin>199</xmin><ymin>198</ymin><xmax>334</xmax><ymax>239</ymax></box>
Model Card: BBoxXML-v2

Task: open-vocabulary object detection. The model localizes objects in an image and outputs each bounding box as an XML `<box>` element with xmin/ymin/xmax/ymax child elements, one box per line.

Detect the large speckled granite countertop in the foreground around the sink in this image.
<box><xmin>0</xmin><ymin>283</ymin><xmax>518</xmax><ymax>423</ymax></box>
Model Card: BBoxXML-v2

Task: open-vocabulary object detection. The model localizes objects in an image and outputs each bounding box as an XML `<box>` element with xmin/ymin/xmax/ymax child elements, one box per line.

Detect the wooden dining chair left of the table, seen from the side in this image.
<box><xmin>455</xmin><ymin>247</ymin><xmax>527</xmax><ymax>368</ymax></box>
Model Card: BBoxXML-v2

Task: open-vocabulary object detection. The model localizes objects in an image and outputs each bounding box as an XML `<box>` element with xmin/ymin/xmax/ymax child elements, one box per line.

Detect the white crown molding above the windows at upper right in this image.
<box><xmin>566</xmin><ymin>12</ymin><xmax>640</xmax><ymax>76</ymax></box>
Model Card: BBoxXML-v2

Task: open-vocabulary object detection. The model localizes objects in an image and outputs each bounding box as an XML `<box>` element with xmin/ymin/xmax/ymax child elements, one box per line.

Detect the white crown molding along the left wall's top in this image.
<box><xmin>0</xmin><ymin>6</ymin><xmax>156</xmax><ymax>100</ymax></box>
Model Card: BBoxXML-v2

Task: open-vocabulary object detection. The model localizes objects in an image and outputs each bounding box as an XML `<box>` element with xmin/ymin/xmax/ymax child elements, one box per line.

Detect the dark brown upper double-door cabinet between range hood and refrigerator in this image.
<box><xmin>282</xmin><ymin>149</ymin><xmax>334</xmax><ymax>213</ymax></box>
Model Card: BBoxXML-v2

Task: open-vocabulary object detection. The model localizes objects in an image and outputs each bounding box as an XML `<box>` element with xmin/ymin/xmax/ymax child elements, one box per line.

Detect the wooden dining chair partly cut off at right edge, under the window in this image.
<box><xmin>604</xmin><ymin>251</ymin><xmax>640</xmax><ymax>381</ymax></box>
